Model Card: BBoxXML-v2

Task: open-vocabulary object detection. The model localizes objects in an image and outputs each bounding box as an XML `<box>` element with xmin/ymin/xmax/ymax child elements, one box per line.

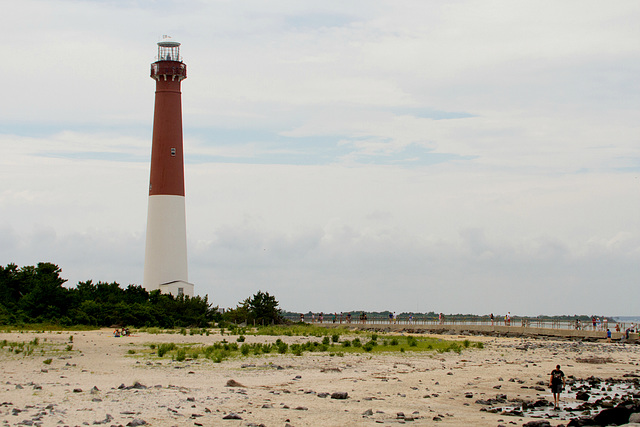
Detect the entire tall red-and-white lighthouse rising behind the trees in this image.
<box><xmin>143</xmin><ymin>36</ymin><xmax>193</xmax><ymax>296</ymax></box>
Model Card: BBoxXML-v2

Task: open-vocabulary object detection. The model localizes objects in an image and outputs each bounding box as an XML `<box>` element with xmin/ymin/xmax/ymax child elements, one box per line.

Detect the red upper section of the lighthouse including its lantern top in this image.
<box><xmin>149</xmin><ymin>40</ymin><xmax>187</xmax><ymax>196</ymax></box>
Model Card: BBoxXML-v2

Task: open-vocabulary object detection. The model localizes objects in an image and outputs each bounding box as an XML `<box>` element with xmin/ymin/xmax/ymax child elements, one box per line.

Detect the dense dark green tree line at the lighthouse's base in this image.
<box><xmin>0</xmin><ymin>262</ymin><xmax>218</xmax><ymax>328</ymax></box>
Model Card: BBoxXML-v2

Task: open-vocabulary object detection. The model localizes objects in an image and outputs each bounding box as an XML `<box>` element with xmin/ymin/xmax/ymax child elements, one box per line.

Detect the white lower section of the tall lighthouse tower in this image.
<box><xmin>144</xmin><ymin>194</ymin><xmax>193</xmax><ymax>296</ymax></box>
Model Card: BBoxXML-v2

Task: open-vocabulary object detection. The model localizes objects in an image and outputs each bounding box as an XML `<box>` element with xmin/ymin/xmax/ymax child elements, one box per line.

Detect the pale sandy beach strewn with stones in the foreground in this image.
<box><xmin>0</xmin><ymin>329</ymin><xmax>640</xmax><ymax>426</ymax></box>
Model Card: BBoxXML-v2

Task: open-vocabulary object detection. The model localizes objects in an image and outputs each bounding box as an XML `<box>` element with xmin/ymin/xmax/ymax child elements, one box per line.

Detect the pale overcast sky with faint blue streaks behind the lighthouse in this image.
<box><xmin>0</xmin><ymin>0</ymin><xmax>640</xmax><ymax>315</ymax></box>
